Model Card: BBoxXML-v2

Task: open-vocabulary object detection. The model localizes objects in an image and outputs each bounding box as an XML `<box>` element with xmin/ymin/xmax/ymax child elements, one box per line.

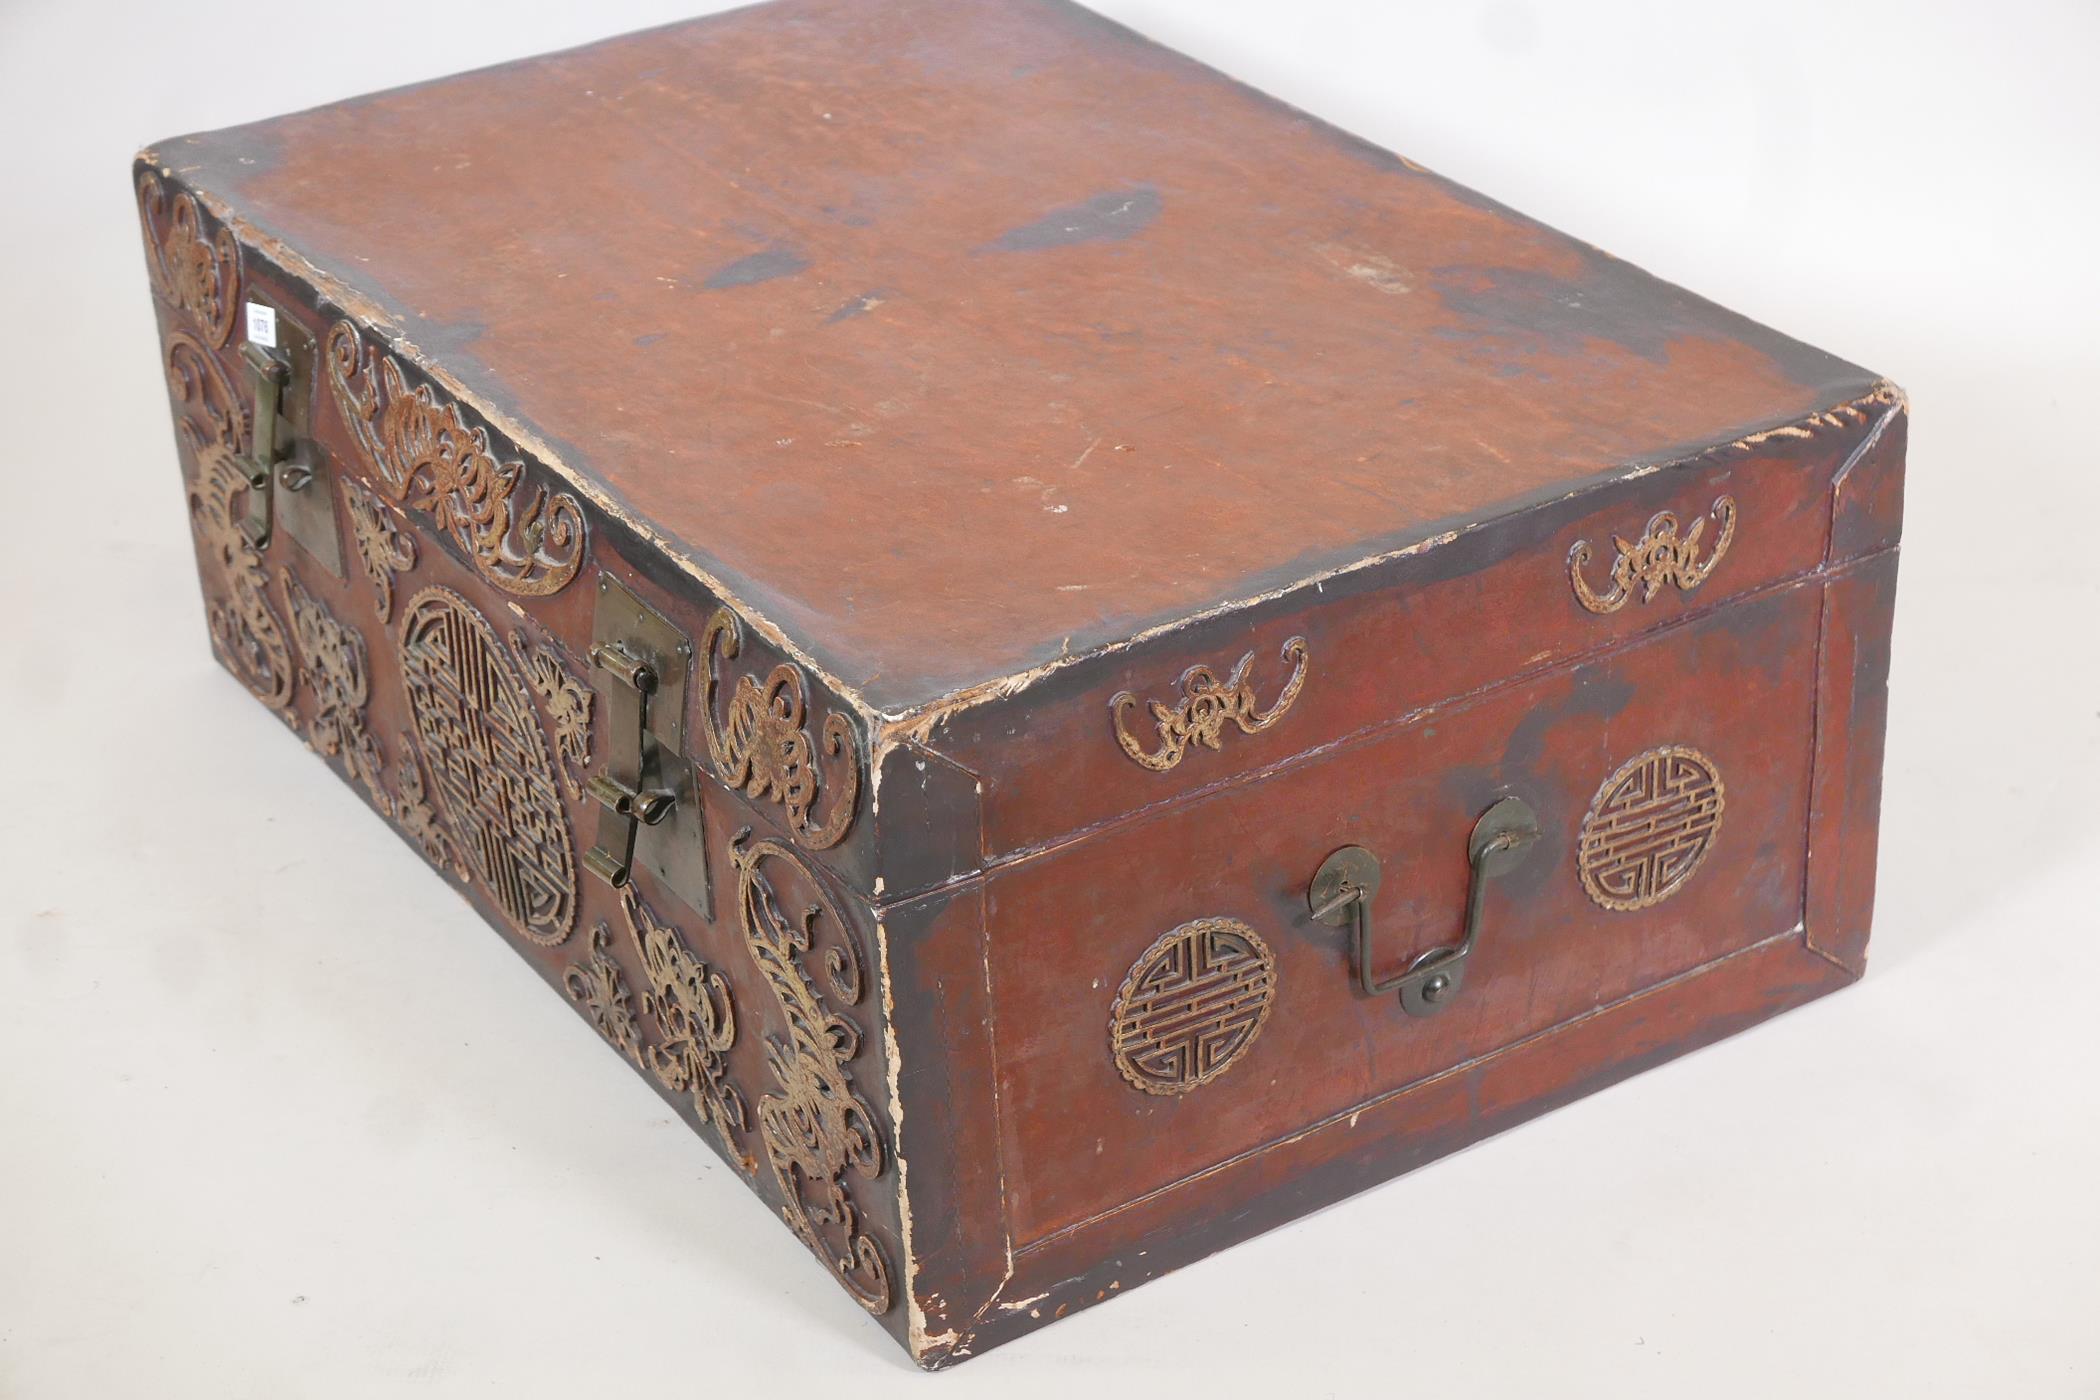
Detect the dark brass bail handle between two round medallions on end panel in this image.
<box><xmin>1306</xmin><ymin>798</ymin><xmax>1539</xmax><ymax>1016</ymax></box>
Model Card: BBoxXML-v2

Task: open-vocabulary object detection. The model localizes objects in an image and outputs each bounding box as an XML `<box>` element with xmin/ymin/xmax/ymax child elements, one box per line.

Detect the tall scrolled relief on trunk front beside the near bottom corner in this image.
<box><xmin>729</xmin><ymin>831</ymin><xmax>893</xmax><ymax>1316</ymax></box>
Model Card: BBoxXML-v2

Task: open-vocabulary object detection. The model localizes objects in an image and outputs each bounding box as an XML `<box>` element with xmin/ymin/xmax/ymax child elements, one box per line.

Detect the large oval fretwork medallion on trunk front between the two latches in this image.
<box><xmin>401</xmin><ymin>588</ymin><xmax>575</xmax><ymax>945</ymax></box>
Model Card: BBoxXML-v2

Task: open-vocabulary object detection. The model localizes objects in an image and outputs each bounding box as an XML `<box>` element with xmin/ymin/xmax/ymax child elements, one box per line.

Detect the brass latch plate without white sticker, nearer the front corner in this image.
<box><xmin>584</xmin><ymin>573</ymin><xmax>714</xmax><ymax>919</ymax></box>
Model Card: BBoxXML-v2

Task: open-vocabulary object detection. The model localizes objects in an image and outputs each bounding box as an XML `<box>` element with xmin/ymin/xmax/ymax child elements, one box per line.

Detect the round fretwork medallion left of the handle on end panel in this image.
<box><xmin>1109</xmin><ymin>919</ymin><xmax>1277</xmax><ymax>1094</ymax></box>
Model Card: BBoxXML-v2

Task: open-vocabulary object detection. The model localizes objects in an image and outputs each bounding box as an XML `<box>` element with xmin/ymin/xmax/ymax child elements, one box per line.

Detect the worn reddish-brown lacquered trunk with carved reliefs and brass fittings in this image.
<box><xmin>134</xmin><ymin>0</ymin><xmax>1905</xmax><ymax>1366</ymax></box>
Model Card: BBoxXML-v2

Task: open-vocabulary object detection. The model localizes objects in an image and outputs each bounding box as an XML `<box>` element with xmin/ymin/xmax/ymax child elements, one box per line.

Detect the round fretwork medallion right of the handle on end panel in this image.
<box><xmin>1575</xmin><ymin>745</ymin><xmax>1724</xmax><ymax>909</ymax></box>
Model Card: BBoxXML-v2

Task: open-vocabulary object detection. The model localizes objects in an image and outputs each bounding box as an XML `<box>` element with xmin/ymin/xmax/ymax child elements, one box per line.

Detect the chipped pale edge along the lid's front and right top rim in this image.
<box><xmin>148</xmin><ymin>147</ymin><xmax>1907</xmax><ymax>793</ymax></box>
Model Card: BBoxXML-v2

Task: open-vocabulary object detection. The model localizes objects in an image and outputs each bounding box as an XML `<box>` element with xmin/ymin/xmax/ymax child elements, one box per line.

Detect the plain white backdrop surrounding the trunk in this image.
<box><xmin>0</xmin><ymin>0</ymin><xmax>2100</xmax><ymax>1400</ymax></box>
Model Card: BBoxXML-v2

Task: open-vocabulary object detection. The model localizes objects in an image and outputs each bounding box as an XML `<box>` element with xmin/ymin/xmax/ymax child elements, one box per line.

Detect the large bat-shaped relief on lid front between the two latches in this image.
<box><xmin>326</xmin><ymin>321</ymin><xmax>586</xmax><ymax>598</ymax></box>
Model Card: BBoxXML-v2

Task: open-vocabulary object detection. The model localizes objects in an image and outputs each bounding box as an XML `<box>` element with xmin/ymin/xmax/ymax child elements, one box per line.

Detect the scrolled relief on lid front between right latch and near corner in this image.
<box><xmin>699</xmin><ymin>607</ymin><xmax>861</xmax><ymax>850</ymax></box>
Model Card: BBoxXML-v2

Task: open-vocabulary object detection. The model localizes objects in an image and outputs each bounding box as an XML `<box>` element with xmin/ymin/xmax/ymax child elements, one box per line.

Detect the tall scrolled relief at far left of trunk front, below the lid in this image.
<box><xmin>166</xmin><ymin>332</ymin><xmax>292</xmax><ymax>722</ymax></box>
